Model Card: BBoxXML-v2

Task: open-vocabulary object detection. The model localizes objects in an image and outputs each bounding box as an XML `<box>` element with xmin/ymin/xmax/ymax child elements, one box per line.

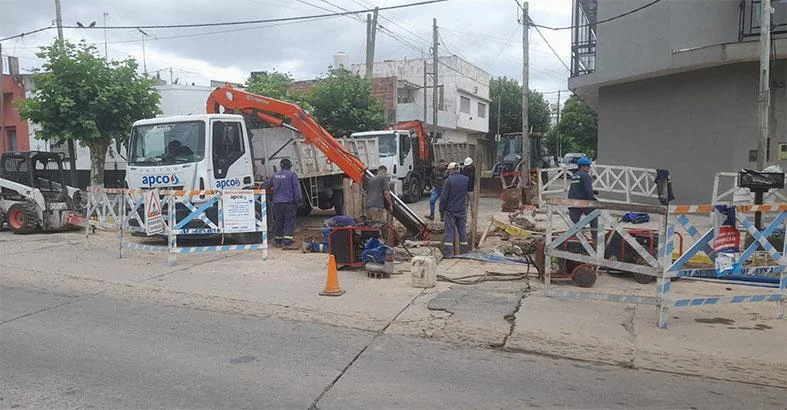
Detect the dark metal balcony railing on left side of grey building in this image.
<box><xmin>571</xmin><ymin>0</ymin><xmax>598</xmax><ymax>77</ymax></box>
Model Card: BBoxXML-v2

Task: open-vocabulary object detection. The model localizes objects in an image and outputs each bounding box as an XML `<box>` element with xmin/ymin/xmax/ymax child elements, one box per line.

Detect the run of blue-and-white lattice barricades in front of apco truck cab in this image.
<box><xmin>85</xmin><ymin>187</ymin><xmax>268</xmax><ymax>264</ymax></box>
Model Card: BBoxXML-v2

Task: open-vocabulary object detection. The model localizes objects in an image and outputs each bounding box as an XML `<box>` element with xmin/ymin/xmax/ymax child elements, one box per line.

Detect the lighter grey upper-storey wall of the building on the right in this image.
<box><xmin>596</xmin><ymin>0</ymin><xmax>740</xmax><ymax>85</ymax></box>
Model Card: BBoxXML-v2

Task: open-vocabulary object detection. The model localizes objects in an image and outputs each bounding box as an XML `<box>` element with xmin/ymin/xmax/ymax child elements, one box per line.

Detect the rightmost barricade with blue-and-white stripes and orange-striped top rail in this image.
<box><xmin>658</xmin><ymin>203</ymin><xmax>787</xmax><ymax>328</ymax></box>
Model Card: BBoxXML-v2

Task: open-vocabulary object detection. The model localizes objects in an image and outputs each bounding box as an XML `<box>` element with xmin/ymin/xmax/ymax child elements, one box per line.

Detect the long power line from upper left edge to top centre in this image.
<box><xmin>0</xmin><ymin>0</ymin><xmax>448</xmax><ymax>41</ymax></box>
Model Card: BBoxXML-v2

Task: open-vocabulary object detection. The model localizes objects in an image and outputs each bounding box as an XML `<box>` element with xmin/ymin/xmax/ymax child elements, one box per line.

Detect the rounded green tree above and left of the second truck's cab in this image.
<box><xmin>307</xmin><ymin>68</ymin><xmax>385</xmax><ymax>137</ymax></box>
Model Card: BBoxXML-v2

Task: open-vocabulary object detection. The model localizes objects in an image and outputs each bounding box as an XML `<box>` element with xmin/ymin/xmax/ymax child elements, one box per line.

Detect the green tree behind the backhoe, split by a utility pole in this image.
<box><xmin>489</xmin><ymin>77</ymin><xmax>551</xmax><ymax>137</ymax></box>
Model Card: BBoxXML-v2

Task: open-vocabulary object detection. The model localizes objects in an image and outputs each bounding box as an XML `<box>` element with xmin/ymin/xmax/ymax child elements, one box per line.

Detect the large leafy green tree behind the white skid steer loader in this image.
<box><xmin>19</xmin><ymin>41</ymin><xmax>159</xmax><ymax>185</ymax></box>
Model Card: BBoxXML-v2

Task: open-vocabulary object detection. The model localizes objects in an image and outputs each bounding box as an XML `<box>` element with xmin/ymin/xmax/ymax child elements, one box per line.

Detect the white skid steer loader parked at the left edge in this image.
<box><xmin>0</xmin><ymin>151</ymin><xmax>84</xmax><ymax>233</ymax></box>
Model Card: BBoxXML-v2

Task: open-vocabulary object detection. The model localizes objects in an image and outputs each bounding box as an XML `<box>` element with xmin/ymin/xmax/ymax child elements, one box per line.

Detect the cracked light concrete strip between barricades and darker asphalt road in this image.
<box><xmin>0</xmin><ymin>232</ymin><xmax>787</xmax><ymax>387</ymax></box>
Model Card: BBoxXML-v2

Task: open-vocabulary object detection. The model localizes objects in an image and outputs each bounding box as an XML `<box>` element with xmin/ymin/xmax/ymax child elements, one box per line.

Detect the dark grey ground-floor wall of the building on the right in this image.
<box><xmin>597</xmin><ymin>59</ymin><xmax>787</xmax><ymax>203</ymax></box>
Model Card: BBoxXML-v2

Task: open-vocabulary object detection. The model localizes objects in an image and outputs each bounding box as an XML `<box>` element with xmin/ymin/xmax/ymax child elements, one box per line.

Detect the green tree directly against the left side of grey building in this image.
<box><xmin>551</xmin><ymin>95</ymin><xmax>598</xmax><ymax>158</ymax></box>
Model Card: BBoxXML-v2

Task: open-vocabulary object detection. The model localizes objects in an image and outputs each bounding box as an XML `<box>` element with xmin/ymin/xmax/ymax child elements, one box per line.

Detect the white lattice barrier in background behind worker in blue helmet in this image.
<box><xmin>538</xmin><ymin>164</ymin><xmax>658</xmax><ymax>204</ymax></box>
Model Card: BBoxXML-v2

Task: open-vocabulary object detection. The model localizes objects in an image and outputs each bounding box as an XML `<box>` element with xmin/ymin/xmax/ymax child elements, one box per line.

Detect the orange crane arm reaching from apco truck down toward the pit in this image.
<box><xmin>206</xmin><ymin>84</ymin><xmax>429</xmax><ymax>240</ymax></box>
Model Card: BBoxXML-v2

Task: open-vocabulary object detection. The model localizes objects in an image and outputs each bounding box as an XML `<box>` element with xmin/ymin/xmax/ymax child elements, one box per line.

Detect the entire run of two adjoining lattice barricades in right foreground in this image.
<box><xmin>544</xmin><ymin>199</ymin><xmax>787</xmax><ymax>328</ymax></box>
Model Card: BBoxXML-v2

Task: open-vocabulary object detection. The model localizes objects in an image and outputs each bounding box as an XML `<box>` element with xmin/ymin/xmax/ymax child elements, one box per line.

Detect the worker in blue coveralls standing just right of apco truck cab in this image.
<box><xmin>265</xmin><ymin>158</ymin><xmax>301</xmax><ymax>248</ymax></box>
